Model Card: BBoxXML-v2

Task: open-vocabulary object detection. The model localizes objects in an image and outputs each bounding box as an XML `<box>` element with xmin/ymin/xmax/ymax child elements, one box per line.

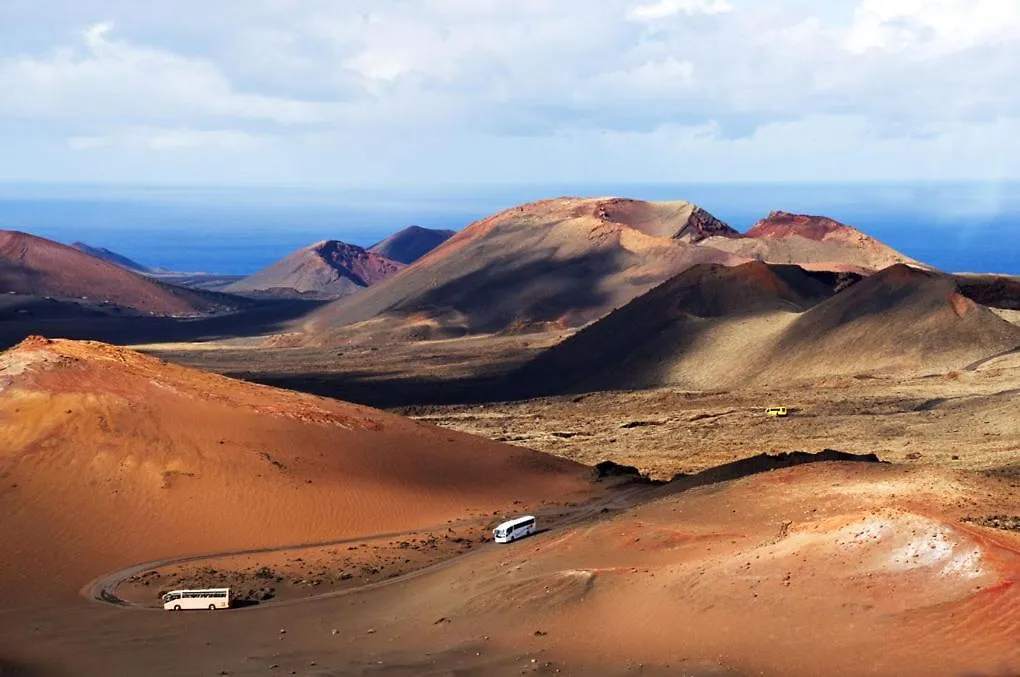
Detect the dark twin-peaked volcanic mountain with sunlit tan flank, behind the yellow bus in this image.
<box><xmin>513</xmin><ymin>262</ymin><xmax>1020</xmax><ymax>397</ymax></box>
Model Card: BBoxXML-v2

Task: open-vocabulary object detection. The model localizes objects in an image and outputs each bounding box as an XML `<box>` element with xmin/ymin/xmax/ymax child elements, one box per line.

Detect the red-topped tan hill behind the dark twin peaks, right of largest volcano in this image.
<box><xmin>705</xmin><ymin>211</ymin><xmax>926</xmax><ymax>274</ymax></box>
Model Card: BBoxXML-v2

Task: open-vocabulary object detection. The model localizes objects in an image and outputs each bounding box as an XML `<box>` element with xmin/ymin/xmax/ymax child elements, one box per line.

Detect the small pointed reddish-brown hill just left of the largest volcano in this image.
<box><xmin>224</xmin><ymin>240</ymin><xmax>404</xmax><ymax>298</ymax></box>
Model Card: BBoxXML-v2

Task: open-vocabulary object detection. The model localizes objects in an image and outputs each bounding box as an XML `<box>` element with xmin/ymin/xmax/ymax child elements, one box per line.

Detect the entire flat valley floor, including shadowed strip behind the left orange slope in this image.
<box><xmin>143</xmin><ymin>334</ymin><xmax>1020</xmax><ymax>479</ymax></box>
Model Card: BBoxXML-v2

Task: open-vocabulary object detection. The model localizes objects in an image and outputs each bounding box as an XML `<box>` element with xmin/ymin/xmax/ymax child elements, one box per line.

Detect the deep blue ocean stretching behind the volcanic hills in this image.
<box><xmin>0</xmin><ymin>183</ymin><xmax>1020</xmax><ymax>275</ymax></box>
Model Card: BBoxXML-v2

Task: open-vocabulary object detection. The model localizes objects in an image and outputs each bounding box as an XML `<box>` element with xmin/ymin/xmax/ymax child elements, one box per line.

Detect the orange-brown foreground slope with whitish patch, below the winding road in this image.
<box><xmin>0</xmin><ymin>456</ymin><xmax>1020</xmax><ymax>677</ymax></box>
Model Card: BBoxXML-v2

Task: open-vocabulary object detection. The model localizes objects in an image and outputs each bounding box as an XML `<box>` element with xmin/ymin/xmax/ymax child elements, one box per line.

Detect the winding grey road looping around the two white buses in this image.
<box><xmin>82</xmin><ymin>484</ymin><xmax>655</xmax><ymax>611</ymax></box>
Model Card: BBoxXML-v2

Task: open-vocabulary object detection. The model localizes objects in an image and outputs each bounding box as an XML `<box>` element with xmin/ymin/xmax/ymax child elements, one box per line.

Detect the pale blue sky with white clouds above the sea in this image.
<box><xmin>0</xmin><ymin>0</ymin><xmax>1020</xmax><ymax>186</ymax></box>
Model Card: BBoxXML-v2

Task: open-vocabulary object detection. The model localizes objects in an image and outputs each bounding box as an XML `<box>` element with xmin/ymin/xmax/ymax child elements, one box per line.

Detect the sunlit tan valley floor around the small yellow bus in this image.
<box><xmin>400</xmin><ymin>356</ymin><xmax>1020</xmax><ymax>479</ymax></box>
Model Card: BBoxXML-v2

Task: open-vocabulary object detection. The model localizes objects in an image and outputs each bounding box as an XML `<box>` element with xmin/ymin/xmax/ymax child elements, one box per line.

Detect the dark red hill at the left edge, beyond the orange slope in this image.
<box><xmin>0</xmin><ymin>230</ymin><xmax>223</xmax><ymax>315</ymax></box>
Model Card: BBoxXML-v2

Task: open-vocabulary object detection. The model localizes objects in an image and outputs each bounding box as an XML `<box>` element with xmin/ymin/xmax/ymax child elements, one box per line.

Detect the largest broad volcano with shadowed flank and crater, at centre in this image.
<box><xmin>297</xmin><ymin>198</ymin><xmax>744</xmax><ymax>342</ymax></box>
